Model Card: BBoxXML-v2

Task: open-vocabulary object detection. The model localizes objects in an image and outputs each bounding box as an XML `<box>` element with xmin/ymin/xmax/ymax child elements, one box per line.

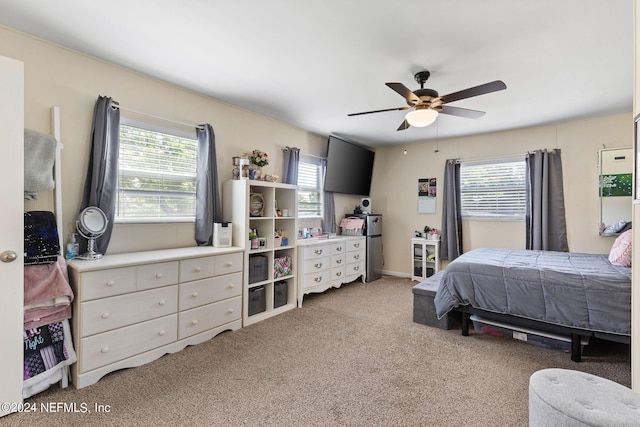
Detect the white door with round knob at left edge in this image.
<box><xmin>0</xmin><ymin>56</ymin><xmax>24</xmax><ymax>417</ymax></box>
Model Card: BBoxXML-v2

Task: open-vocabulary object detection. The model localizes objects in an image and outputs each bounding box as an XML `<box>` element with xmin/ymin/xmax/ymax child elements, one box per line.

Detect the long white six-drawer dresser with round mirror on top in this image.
<box><xmin>68</xmin><ymin>247</ymin><xmax>243</xmax><ymax>388</ymax></box>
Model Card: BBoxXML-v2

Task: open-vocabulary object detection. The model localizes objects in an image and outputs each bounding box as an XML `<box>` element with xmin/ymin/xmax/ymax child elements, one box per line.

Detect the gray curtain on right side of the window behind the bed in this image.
<box><xmin>526</xmin><ymin>150</ymin><xmax>569</xmax><ymax>252</ymax></box>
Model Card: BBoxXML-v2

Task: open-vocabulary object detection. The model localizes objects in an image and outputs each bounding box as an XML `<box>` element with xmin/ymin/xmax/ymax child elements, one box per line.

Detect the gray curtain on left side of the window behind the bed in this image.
<box><xmin>440</xmin><ymin>159</ymin><xmax>462</xmax><ymax>261</ymax></box>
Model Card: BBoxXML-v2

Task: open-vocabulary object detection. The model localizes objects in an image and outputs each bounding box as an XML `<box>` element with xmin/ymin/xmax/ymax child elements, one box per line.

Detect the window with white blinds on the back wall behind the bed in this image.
<box><xmin>460</xmin><ymin>158</ymin><xmax>526</xmax><ymax>220</ymax></box>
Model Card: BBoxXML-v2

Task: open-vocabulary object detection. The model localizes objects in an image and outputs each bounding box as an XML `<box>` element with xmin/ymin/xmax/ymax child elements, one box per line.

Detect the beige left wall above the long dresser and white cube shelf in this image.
<box><xmin>0</xmin><ymin>26</ymin><xmax>359</xmax><ymax>253</ymax></box>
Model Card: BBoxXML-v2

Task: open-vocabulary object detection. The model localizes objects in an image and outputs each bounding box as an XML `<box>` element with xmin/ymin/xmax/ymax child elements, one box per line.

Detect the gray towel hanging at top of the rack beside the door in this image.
<box><xmin>24</xmin><ymin>129</ymin><xmax>58</xmax><ymax>200</ymax></box>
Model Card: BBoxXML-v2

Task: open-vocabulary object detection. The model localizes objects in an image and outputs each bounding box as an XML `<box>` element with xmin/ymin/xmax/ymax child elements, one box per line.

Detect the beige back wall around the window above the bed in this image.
<box><xmin>371</xmin><ymin>113</ymin><xmax>633</xmax><ymax>275</ymax></box>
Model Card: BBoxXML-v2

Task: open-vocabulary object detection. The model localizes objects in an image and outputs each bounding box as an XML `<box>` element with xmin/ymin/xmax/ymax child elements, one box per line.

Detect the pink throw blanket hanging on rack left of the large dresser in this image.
<box><xmin>24</xmin><ymin>255</ymin><xmax>73</xmax><ymax>329</ymax></box>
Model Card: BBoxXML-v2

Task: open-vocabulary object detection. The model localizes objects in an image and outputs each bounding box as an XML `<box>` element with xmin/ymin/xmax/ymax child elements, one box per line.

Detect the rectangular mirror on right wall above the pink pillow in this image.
<box><xmin>599</xmin><ymin>148</ymin><xmax>633</xmax><ymax>236</ymax></box>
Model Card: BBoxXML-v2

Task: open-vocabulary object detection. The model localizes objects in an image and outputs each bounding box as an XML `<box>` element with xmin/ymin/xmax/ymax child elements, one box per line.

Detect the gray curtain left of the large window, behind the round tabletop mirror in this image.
<box><xmin>78</xmin><ymin>96</ymin><xmax>120</xmax><ymax>253</ymax></box>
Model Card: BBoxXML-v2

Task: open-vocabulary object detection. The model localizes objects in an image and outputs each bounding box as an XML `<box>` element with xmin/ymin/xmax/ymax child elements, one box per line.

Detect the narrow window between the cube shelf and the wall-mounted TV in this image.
<box><xmin>298</xmin><ymin>156</ymin><xmax>324</xmax><ymax>218</ymax></box>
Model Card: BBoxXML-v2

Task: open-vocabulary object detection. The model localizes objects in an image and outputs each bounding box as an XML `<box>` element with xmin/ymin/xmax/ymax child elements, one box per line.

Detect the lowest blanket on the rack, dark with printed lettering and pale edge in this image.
<box><xmin>22</xmin><ymin>320</ymin><xmax>77</xmax><ymax>399</ymax></box>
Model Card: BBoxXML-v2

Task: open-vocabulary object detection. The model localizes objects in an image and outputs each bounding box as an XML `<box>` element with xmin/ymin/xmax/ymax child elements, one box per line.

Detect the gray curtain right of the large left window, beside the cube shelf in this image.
<box><xmin>195</xmin><ymin>123</ymin><xmax>222</xmax><ymax>246</ymax></box>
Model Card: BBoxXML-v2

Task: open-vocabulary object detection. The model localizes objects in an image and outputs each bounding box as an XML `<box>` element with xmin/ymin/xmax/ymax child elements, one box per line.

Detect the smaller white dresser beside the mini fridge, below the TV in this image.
<box><xmin>298</xmin><ymin>236</ymin><xmax>366</xmax><ymax>307</ymax></box>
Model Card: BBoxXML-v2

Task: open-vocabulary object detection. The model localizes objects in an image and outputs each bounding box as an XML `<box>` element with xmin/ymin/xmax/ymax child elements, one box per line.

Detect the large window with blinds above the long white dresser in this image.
<box><xmin>115</xmin><ymin>119</ymin><xmax>198</xmax><ymax>222</ymax></box>
